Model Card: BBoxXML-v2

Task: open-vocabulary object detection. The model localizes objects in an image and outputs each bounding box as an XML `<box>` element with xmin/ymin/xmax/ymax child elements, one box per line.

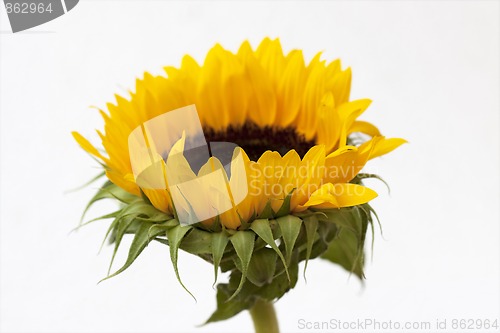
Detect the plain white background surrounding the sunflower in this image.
<box><xmin>0</xmin><ymin>0</ymin><xmax>500</xmax><ymax>332</ymax></box>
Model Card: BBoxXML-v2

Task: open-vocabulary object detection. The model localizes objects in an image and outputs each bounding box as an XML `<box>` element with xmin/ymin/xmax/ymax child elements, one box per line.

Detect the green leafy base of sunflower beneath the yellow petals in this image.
<box><xmin>81</xmin><ymin>175</ymin><xmax>376</xmax><ymax>323</ymax></box>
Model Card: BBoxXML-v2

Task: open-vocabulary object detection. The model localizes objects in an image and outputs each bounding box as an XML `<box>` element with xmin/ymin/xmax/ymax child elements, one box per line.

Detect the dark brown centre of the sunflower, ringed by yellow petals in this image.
<box><xmin>203</xmin><ymin>122</ymin><xmax>315</xmax><ymax>161</ymax></box>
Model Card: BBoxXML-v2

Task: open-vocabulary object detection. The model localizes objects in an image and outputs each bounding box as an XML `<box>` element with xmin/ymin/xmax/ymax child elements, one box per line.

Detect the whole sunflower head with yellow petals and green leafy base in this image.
<box><xmin>73</xmin><ymin>38</ymin><xmax>405</xmax><ymax>330</ymax></box>
